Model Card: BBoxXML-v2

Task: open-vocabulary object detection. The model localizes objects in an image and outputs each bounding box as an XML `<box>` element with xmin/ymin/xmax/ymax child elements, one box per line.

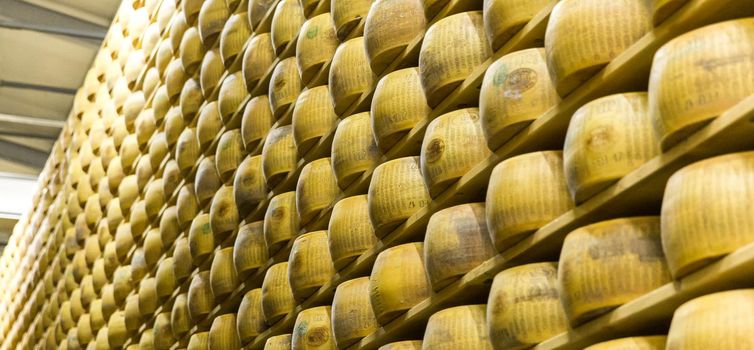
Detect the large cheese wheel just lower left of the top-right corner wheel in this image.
<box><xmin>563</xmin><ymin>92</ymin><xmax>660</xmax><ymax>203</ymax></box>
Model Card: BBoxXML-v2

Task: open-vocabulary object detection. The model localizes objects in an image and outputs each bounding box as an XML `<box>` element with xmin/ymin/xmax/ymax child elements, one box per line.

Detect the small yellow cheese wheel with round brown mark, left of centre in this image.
<box><xmin>264</xmin><ymin>191</ymin><xmax>299</xmax><ymax>255</ymax></box>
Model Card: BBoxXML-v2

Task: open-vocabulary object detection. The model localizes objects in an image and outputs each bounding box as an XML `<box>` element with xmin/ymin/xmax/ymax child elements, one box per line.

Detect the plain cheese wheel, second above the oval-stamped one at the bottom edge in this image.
<box><xmin>296</xmin><ymin>158</ymin><xmax>340</xmax><ymax>225</ymax></box>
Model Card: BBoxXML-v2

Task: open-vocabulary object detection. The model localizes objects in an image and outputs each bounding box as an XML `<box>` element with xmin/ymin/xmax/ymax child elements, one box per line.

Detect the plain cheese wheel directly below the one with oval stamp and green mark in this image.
<box><xmin>486</xmin><ymin>151</ymin><xmax>574</xmax><ymax>252</ymax></box>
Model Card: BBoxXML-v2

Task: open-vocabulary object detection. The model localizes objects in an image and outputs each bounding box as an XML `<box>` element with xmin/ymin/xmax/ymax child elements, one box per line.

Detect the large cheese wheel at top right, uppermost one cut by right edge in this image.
<box><xmin>649</xmin><ymin>18</ymin><xmax>754</xmax><ymax>150</ymax></box>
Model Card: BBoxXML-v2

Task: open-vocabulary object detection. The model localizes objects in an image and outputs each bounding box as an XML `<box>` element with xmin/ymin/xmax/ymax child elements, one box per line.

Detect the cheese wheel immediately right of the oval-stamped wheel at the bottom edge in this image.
<box><xmin>332</xmin><ymin>277</ymin><xmax>380</xmax><ymax>349</ymax></box>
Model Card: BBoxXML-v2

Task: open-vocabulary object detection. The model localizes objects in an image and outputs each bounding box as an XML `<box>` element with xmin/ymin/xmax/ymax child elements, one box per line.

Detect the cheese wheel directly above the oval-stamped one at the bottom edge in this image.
<box><xmin>288</xmin><ymin>231</ymin><xmax>335</xmax><ymax>303</ymax></box>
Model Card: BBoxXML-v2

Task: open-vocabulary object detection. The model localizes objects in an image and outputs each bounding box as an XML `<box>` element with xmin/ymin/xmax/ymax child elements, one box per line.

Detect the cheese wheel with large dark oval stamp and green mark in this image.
<box><xmin>479</xmin><ymin>47</ymin><xmax>560</xmax><ymax>150</ymax></box>
